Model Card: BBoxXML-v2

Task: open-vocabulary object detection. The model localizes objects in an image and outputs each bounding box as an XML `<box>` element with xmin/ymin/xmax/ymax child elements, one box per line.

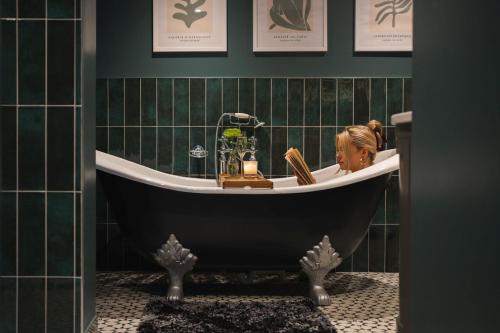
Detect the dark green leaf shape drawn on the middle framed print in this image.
<box><xmin>269</xmin><ymin>0</ymin><xmax>311</xmax><ymax>31</ymax></box>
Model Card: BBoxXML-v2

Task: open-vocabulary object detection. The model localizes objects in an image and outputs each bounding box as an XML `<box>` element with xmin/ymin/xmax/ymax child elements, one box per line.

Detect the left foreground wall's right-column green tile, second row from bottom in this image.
<box><xmin>47</xmin><ymin>193</ymin><xmax>75</xmax><ymax>276</ymax></box>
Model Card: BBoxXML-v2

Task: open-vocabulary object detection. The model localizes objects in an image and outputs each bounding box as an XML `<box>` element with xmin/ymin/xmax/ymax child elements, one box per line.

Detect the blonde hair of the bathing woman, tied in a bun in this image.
<box><xmin>336</xmin><ymin>120</ymin><xmax>386</xmax><ymax>170</ymax></box>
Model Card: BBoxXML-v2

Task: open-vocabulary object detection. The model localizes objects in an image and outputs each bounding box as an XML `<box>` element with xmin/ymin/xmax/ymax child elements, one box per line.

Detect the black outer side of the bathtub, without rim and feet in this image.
<box><xmin>98</xmin><ymin>171</ymin><xmax>391</xmax><ymax>271</ymax></box>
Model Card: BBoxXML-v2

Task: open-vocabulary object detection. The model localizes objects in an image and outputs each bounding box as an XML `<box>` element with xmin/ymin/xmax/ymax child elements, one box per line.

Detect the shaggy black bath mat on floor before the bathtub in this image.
<box><xmin>137</xmin><ymin>297</ymin><xmax>336</xmax><ymax>333</ymax></box>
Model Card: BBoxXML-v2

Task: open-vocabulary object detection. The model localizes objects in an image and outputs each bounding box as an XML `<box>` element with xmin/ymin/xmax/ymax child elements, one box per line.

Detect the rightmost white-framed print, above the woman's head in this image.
<box><xmin>354</xmin><ymin>0</ymin><xmax>414</xmax><ymax>52</ymax></box>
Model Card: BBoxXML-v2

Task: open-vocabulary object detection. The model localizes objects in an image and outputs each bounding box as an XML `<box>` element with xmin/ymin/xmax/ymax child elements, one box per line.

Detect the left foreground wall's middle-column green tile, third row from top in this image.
<box><xmin>18</xmin><ymin>107</ymin><xmax>45</xmax><ymax>190</ymax></box>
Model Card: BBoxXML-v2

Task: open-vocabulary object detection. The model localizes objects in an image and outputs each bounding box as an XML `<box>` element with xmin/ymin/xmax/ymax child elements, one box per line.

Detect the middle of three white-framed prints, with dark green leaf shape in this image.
<box><xmin>253</xmin><ymin>0</ymin><xmax>328</xmax><ymax>52</ymax></box>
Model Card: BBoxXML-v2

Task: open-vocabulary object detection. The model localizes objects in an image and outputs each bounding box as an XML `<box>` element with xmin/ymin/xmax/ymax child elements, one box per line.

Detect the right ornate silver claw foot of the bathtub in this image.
<box><xmin>300</xmin><ymin>236</ymin><xmax>342</xmax><ymax>305</ymax></box>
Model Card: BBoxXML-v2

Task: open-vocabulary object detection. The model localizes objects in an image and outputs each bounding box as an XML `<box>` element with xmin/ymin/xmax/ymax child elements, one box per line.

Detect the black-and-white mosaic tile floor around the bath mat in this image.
<box><xmin>97</xmin><ymin>272</ymin><xmax>399</xmax><ymax>333</ymax></box>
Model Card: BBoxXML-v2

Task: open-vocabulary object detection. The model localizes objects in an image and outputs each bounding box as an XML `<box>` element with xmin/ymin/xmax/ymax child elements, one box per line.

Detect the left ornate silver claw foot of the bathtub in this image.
<box><xmin>154</xmin><ymin>234</ymin><xmax>198</xmax><ymax>303</ymax></box>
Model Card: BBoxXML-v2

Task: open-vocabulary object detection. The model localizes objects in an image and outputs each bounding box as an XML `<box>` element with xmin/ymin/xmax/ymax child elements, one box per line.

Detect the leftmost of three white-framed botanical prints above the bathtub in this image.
<box><xmin>153</xmin><ymin>0</ymin><xmax>227</xmax><ymax>52</ymax></box>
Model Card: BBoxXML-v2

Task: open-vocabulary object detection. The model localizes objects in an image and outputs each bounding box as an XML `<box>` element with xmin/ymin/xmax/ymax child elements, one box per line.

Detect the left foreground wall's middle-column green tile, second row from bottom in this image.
<box><xmin>18</xmin><ymin>193</ymin><xmax>45</xmax><ymax>276</ymax></box>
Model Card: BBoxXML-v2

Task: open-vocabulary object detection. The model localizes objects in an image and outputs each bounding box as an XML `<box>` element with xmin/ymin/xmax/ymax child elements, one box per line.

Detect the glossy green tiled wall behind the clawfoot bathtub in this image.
<box><xmin>97</xmin><ymin>78</ymin><xmax>411</xmax><ymax>272</ymax></box>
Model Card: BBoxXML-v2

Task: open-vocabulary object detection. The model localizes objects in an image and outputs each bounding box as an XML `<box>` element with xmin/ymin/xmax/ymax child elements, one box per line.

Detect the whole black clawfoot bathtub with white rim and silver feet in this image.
<box><xmin>96</xmin><ymin>150</ymin><xmax>399</xmax><ymax>305</ymax></box>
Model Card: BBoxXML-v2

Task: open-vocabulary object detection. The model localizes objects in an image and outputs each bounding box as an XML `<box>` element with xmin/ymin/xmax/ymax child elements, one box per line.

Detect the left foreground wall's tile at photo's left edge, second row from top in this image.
<box><xmin>0</xmin><ymin>21</ymin><xmax>17</xmax><ymax>104</ymax></box>
